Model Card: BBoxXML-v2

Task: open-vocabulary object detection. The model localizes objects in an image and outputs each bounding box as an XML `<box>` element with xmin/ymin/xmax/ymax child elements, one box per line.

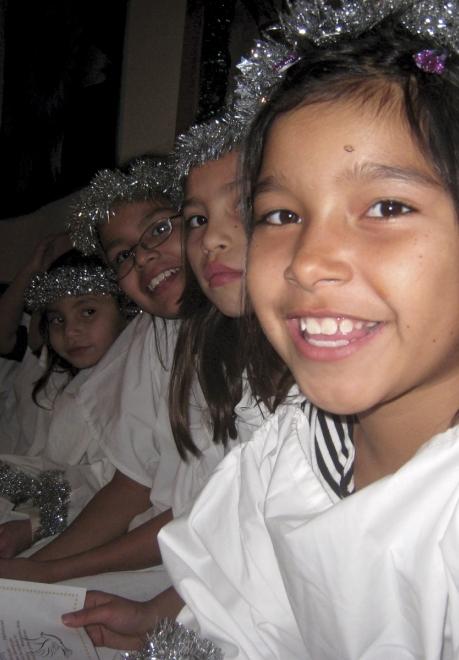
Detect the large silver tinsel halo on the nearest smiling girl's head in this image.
<box><xmin>233</xmin><ymin>0</ymin><xmax>459</xmax><ymax>123</ymax></box>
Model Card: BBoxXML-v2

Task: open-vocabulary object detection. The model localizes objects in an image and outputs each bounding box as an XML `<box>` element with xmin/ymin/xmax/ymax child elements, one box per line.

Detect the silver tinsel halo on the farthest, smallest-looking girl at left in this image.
<box><xmin>24</xmin><ymin>265</ymin><xmax>120</xmax><ymax>312</ymax></box>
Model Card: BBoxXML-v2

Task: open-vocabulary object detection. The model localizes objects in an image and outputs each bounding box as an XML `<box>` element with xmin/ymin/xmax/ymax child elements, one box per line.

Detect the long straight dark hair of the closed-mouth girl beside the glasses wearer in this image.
<box><xmin>169</xmin><ymin>235</ymin><xmax>245</xmax><ymax>460</ymax></box>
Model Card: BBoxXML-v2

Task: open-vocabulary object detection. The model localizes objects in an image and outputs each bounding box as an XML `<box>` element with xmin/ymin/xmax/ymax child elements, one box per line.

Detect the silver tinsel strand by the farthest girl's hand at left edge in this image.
<box><xmin>0</xmin><ymin>461</ymin><xmax>71</xmax><ymax>540</ymax></box>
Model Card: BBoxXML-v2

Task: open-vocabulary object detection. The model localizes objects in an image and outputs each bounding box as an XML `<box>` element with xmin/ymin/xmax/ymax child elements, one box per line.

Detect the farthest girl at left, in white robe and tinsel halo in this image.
<box><xmin>0</xmin><ymin>250</ymin><xmax>126</xmax><ymax>557</ymax></box>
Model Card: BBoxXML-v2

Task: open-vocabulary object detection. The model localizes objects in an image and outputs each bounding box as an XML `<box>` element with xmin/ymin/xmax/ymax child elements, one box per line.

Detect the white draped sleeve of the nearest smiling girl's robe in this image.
<box><xmin>159</xmin><ymin>412</ymin><xmax>303</xmax><ymax>660</ymax></box>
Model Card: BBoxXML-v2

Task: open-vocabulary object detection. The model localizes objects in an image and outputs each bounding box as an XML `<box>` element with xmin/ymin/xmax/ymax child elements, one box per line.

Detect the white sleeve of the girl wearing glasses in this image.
<box><xmin>79</xmin><ymin>314</ymin><xmax>180</xmax><ymax>513</ymax></box>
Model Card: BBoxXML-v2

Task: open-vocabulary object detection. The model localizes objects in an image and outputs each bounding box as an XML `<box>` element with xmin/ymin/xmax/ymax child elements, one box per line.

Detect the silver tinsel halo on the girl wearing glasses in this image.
<box><xmin>67</xmin><ymin>158</ymin><xmax>180</xmax><ymax>254</ymax></box>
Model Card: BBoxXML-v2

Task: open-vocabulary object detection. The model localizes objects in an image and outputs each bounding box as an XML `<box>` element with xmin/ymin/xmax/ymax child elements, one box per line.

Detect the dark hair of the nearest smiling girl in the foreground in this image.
<box><xmin>242</xmin><ymin>16</ymin><xmax>459</xmax><ymax>406</ymax></box>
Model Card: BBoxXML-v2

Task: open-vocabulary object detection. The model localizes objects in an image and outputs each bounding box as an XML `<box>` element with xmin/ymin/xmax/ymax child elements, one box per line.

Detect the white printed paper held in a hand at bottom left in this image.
<box><xmin>0</xmin><ymin>579</ymin><xmax>99</xmax><ymax>660</ymax></box>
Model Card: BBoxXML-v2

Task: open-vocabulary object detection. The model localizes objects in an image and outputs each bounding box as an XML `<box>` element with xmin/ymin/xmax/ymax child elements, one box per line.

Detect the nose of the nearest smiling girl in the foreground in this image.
<box><xmin>285</xmin><ymin>223</ymin><xmax>353</xmax><ymax>290</ymax></box>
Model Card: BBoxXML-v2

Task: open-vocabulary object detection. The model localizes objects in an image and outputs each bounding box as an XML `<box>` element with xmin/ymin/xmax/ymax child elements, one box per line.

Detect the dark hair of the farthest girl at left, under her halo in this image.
<box><xmin>32</xmin><ymin>249</ymin><xmax>118</xmax><ymax>408</ymax></box>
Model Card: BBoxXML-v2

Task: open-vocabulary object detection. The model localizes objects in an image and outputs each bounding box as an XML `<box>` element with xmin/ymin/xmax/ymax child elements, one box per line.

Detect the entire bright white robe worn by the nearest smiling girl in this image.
<box><xmin>160</xmin><ymin>404</ymin><xmax>459</xmax><ymax>660</ymax></box>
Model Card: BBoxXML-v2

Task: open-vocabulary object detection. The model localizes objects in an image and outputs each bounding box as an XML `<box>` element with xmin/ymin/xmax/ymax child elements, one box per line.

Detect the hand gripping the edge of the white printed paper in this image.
<box><xmin>62</xmin><ymin>591</ymin><xmax>156</xmax><ymax>650</ymax></box>
